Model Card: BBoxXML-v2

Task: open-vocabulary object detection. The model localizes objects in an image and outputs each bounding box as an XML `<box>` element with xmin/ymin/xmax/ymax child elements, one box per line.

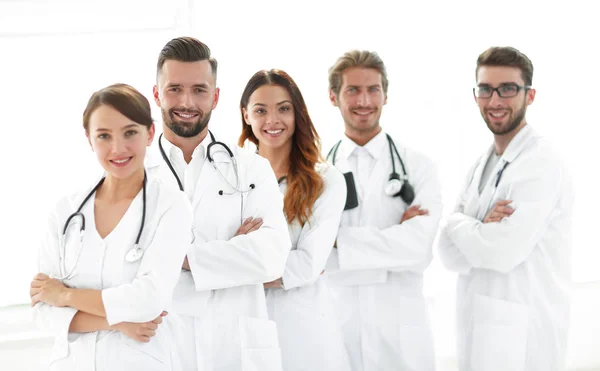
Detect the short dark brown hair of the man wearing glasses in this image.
<box><xmin>475</xmin><ymin>46</ymin><xmax>533</xmax><ymax>86</ymax></box>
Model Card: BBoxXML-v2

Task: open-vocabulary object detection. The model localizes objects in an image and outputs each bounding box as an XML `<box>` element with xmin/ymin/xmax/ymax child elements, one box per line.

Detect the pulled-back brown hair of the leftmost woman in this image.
<box><xmin>83</xmin><ymin>84</ymin><xmax>152</xmax><ymax>132</ymax></box>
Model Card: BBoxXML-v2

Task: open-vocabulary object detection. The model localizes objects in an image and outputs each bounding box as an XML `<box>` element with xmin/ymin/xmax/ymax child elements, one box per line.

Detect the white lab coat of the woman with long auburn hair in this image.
<box><xmin>266</xmin><ymin>164</ymin><xmax>350</xmax><ymax>371</ymax></box>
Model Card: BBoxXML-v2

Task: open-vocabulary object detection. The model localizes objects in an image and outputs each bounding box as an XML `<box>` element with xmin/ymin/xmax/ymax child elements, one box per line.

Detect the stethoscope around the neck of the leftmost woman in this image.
<box><xmin>56</xmin><ymin>171</ymin><xmax>148</xmax><ymax>280</ymax></box>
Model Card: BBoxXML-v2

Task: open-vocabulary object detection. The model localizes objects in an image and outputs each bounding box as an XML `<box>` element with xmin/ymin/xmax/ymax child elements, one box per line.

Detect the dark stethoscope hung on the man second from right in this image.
<box><xmin>327</xmin><ymin>133</ymin><xmax>415</xmax><ymax>210</ymax></box>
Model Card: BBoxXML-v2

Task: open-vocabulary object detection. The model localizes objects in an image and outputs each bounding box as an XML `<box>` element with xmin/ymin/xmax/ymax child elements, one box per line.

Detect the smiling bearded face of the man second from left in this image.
<box><xmin>154</xmin><ymin>60</ymin><xmax>219</xmax><ymax>138</ymax></box>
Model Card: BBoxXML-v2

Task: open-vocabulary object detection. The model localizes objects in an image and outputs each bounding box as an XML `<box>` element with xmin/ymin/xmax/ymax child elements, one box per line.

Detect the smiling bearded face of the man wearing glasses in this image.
<box><xmin>475</xmin><ymin>66</ymin><xmax>535</xmax><ymax>135</ymax></box>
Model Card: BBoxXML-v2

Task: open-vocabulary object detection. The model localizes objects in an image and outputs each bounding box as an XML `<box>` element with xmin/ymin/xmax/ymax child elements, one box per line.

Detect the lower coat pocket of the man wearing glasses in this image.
<box><xmin>470</xmin><ymin>295</ymin><xmax>529</xmax><ymax>371</ymax></box>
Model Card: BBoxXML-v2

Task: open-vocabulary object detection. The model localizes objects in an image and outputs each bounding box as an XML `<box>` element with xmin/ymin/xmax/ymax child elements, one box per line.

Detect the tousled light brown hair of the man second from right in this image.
<box><xmin>329</xmin><ymin>50</ymin><xmax>389</xmax><ymax>95</ymax></box>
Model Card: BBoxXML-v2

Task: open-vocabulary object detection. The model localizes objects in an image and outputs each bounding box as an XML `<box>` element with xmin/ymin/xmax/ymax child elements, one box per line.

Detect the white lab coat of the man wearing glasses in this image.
<box><xmin>439</xmin><ymin>125</ymin><xmax>573</xmax><ymax>371</ymax></box>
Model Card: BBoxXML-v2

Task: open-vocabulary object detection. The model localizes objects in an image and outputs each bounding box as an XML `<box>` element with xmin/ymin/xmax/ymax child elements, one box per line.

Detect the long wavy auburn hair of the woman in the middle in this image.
<box><xmin>238</xmin><ymin>69</ymin><xmax>324</xmax><ymax>225</ymax></box>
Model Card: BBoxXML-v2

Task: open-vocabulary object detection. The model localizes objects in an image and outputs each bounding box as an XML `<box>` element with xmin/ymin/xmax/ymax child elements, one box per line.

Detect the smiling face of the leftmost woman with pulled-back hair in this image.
<box><xmin>87</xmin><ymin>105</ymin><xmax>154</xmax><ymax>179</ymax></box>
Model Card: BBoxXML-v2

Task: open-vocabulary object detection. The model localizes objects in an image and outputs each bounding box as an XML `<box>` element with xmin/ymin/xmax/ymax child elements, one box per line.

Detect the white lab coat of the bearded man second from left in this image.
<box><xmin>147</xmin><ymin>138</ymin><xmax>291</xmax><ymax>371</ymax></box>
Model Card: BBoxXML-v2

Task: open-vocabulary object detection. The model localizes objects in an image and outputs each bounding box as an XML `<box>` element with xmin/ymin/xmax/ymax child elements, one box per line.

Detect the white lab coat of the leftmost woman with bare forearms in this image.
<box><xmin>33</xmin><ymin>176</ymin><xmax>192</xmax><ymax>371</ymax></box>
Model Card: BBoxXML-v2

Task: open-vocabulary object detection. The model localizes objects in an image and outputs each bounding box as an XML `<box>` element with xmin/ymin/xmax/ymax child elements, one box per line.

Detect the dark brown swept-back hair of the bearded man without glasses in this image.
<box><xmin>156</xmin><ymin>37</ymin><xmax>218</xmax><ymax>80</ymax></box>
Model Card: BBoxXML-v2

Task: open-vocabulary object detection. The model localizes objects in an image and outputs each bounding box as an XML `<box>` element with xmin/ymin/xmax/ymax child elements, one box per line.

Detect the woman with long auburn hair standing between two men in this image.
<box><xmin>239</xmin><ymin>70</ymin><xmax>350</xmax><ymax>371</ymax></box>
